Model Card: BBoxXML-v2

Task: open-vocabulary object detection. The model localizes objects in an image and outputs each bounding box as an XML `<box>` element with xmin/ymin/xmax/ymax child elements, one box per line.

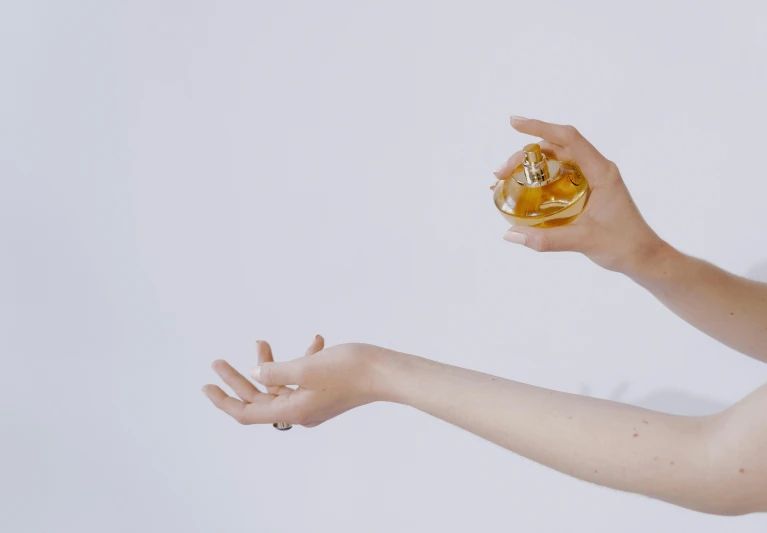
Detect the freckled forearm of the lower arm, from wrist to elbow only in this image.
<box><xmin>379</xmin><ymin>354</ymin><xmax>724</xmax><ymax>512</ymax></box>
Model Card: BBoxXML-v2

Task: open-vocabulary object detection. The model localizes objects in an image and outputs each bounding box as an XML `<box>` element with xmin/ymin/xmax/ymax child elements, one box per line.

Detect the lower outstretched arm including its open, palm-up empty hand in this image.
<box><xmin>203</xmin><ymin>338</ymin><xmax>767</xmax><ymax>515</ymax></box>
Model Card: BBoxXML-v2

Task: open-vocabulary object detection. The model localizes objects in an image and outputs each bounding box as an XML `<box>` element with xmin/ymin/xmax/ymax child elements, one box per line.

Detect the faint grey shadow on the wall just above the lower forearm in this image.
<box><xmin>581</xmin><ymin>383</ymin><xmax>728</xmax><ymax>416</ymax></box>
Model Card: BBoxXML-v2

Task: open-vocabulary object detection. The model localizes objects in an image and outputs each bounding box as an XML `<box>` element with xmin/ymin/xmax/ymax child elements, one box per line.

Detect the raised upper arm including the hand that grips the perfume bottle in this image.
<box><xmin>495</xmin><ymin>117</ymin><xmax>767</xmax><ymax>362</ymax></box>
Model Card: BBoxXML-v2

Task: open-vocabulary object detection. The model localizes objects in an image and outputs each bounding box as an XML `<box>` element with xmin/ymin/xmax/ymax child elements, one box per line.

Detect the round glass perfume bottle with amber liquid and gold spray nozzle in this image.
<box><xmin>493</xmin><ymin>144</ymin><xmax>589</xmax><ymax>228</ymax></box>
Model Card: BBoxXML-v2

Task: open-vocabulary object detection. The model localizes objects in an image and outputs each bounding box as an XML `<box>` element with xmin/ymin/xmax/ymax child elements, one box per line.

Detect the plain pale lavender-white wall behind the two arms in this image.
<box><xmin>0</xmin><ymin>0</ymin><xmax>767</xmax><ymax>533</ymax></box>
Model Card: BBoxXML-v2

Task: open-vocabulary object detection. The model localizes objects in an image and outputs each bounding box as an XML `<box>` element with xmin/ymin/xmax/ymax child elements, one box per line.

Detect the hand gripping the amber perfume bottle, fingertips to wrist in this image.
<box><xmin>495</xmin><ymin>117</ymin><xmax>664</xmax><ymax>274</ymax></box>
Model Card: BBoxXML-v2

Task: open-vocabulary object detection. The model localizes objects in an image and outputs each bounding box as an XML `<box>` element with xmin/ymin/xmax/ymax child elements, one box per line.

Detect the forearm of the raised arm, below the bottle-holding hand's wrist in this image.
<box><xmin>629</xmin><ymin>243</ymin><xmax>767</xmax><ymax>361</ymax></box>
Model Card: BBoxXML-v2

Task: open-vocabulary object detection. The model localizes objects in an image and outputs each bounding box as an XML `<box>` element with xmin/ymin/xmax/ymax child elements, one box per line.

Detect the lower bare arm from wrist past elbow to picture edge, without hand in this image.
<box><xmin>380</xmin><ymin>357</ymin><xmax>767</xmax><ymax>515</ymax></box>
